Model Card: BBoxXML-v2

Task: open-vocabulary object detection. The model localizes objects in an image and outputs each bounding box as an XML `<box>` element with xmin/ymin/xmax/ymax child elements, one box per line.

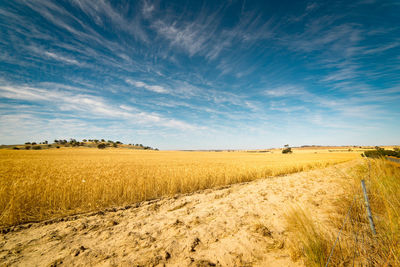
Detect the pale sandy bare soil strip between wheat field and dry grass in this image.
<box><xmin>0</xmin><ymin>161</ymin><xmax>357</xmax><ymax>266</ymax></box>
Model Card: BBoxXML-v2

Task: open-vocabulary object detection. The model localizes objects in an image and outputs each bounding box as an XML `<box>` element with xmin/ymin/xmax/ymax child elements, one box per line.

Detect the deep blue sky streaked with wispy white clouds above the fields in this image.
<box><xmin>0</xmin><ymin>0</ymin><xmax>400</xmax><ymax>149</ymax></box>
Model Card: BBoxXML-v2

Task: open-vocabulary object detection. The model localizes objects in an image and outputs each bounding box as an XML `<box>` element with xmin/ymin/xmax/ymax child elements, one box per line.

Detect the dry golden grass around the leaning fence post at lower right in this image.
<box><xmin>288</xmin><ymin>159</ymin><xmax>400</xmax><ymax>266</ymax></box>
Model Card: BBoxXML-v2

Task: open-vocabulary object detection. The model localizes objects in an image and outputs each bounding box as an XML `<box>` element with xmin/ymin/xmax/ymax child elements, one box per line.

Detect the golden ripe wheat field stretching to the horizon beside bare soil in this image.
<box><xmin>0</xmin><ymin>148</ymin><xmax>359</xmax><ymax>226</ymax></box>
